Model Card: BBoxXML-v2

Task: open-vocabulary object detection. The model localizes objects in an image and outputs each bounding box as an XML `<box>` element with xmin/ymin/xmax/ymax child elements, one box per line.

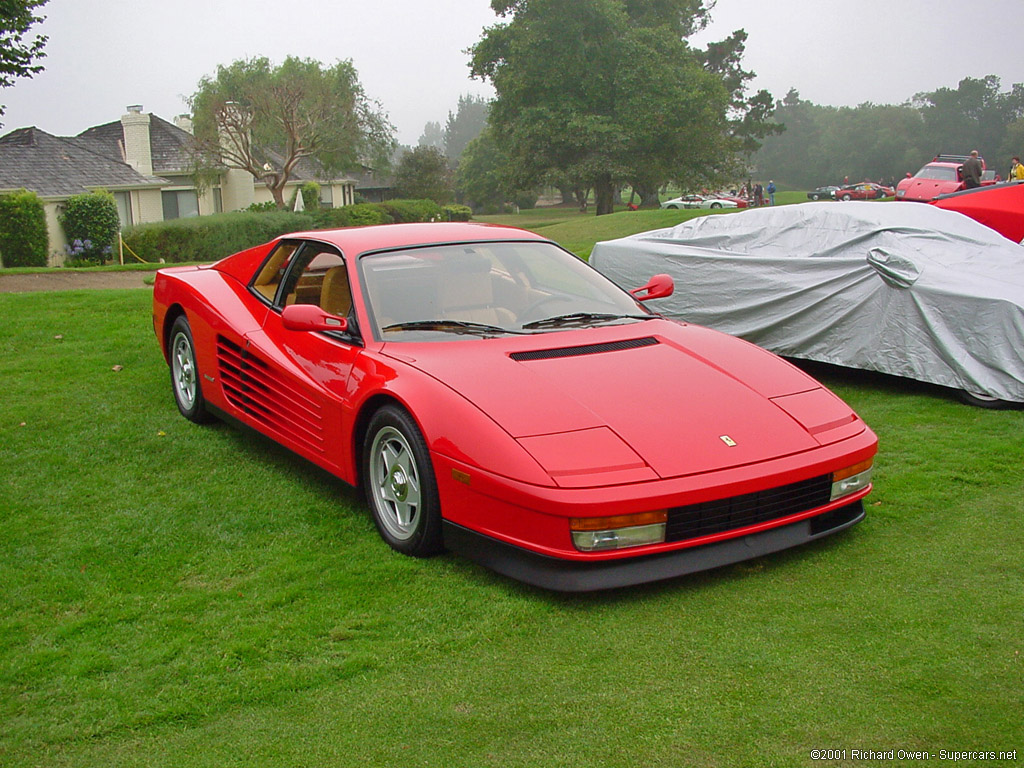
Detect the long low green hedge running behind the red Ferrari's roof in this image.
<box><xmin>123</xmin><ymin>200</ymin><xmax>469</xmax><ymax>263</ymax></box>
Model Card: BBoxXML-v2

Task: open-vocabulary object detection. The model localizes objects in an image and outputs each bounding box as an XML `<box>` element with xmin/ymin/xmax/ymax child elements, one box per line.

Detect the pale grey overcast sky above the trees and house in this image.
<box><xmin>0</xmin><ymin>0</ymin><xmax>1024</xmax><ymax>144</ymax></box>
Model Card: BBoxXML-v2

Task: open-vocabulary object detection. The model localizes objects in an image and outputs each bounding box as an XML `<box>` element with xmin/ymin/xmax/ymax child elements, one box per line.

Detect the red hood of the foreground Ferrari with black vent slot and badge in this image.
<box><xmin>385</xmin><ymin>319</ymin><xmax>863</xmax><ymax>485</ymax></box>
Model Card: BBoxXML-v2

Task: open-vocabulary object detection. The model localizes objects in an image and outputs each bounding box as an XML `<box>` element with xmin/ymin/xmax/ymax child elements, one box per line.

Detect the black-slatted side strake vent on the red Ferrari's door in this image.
<box><xmin>217</xmin><ymin>336</ymin><xmax>324</xmax><ymax>454</ymax></box>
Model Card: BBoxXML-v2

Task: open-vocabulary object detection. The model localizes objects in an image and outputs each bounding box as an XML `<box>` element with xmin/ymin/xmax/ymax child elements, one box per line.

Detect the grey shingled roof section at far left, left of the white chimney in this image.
<box><xmin>0</xmin><ymin>127</ymin><xmax>167</xmax><ymax>198</ymax></box>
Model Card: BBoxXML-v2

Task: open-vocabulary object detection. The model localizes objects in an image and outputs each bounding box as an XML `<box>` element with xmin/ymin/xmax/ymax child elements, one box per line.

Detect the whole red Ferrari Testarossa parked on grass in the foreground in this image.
<box><xmin>153</xmin><ymin>223</ymin><xmax>877</xmax><ymax>591</ymax></box>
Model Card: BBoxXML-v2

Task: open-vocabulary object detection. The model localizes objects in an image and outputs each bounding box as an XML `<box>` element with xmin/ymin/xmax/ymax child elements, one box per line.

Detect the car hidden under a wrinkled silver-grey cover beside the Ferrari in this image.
<box><xmin>591</xmin><ymin>202</ymin><xmax>1024</xmax><ymax>407</ymax></box>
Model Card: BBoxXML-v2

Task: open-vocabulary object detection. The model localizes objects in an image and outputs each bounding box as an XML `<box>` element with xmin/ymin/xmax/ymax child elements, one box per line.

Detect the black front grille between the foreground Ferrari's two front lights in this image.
<box><xmin>665</xmin><ymin>475</ymin><xmax>831</xmax><ymax>542</ymax></box>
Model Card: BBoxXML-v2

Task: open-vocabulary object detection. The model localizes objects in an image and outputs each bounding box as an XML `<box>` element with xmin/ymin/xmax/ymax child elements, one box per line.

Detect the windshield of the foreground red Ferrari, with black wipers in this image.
<box><xmin>359</xmin><ymin>242</ymin><xmax>655</xmax><ymax>341</ymax></box>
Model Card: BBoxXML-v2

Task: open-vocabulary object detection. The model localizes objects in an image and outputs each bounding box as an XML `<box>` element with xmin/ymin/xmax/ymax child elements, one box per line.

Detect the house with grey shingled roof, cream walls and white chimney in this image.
<box><xmin>0</xmin><ymin>105</ymin><xmax>356</xmax><ymax>265</ymax></box>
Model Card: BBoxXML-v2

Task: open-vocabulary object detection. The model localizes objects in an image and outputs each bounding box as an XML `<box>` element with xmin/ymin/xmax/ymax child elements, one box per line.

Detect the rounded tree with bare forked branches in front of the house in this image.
<box><xmin>189</xmin><ymin>56</ymin><xmax>394</xmax><ymax>208</ymax></box>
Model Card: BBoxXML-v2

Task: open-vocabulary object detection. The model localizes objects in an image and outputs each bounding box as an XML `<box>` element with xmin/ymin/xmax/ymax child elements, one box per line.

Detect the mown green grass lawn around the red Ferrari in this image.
<box><xmin>0</xmin><ymin>212</ymin><xmax>1024</xmax><ymax>768</ymax></box>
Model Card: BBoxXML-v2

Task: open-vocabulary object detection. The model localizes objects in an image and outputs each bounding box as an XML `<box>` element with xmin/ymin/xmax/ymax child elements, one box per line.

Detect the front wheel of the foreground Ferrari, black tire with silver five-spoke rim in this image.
<box><xmin>362</xmin><ymin>406</ymin><xmax>444</xmax><ymax>557</ymax></box>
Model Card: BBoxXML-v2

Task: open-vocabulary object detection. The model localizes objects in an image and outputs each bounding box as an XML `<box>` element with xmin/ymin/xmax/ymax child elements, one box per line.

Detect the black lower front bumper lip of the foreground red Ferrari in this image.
<box><xmin>443</xmin><ymin>500</ymin><xmax>864</xmax><ymax>592</ymax></box>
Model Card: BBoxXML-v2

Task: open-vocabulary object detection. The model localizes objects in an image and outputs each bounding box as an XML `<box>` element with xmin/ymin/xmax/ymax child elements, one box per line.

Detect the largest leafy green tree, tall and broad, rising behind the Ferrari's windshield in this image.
<box><xmin>471</xmin><ymin>0</ymin><xmax>770</xmax><ymax>215</ymax></box>
